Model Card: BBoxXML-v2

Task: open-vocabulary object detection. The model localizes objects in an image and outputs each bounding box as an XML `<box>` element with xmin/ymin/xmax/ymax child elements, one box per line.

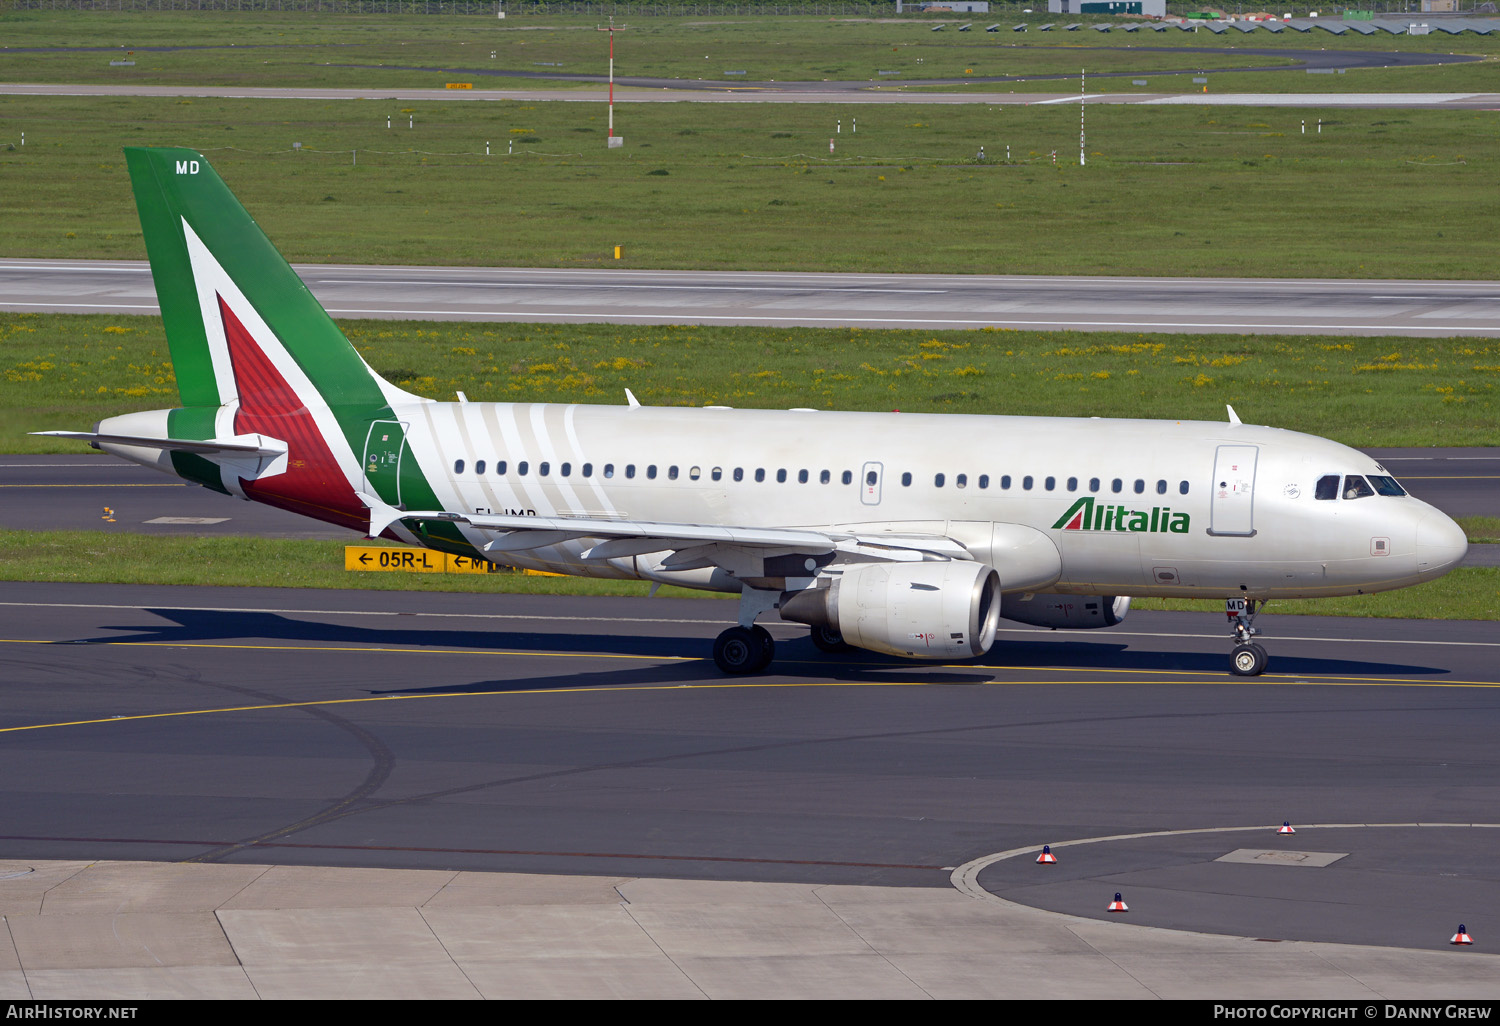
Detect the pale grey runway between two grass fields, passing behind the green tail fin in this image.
<box><xmin>0</xmin><ymin>260</ymin><xmax>1500</xmax><ymax>338</ymax></box>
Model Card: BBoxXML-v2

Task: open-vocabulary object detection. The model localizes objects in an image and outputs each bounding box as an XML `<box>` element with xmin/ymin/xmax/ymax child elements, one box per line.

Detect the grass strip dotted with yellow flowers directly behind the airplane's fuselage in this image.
<box><xmin>0</xmin><ymin>306</ymin><xmax>1500</xmax><ymax>452</ymax></box>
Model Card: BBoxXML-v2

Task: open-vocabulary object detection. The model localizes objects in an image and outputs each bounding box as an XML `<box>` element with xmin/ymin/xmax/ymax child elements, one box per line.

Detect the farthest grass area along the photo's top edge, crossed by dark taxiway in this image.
<box><xmin>0</xmin><ymin>11</ymin><xmax>1500</xmax><ymax>92</ymax></box>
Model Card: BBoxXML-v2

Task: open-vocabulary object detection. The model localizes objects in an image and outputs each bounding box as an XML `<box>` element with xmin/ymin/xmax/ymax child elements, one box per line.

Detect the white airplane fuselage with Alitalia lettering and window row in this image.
<box><xmin>101</xmin><ymin>402</ymin><xmax>1467</xmax><ymax>600</ymax></box>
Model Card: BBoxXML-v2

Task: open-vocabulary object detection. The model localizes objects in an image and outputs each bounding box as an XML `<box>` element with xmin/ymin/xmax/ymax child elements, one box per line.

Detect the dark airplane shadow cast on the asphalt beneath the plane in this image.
<box><xmin>70</xmin><ymin>609</ymin><xmax>1452</xmax><ymax>695</ymax></box>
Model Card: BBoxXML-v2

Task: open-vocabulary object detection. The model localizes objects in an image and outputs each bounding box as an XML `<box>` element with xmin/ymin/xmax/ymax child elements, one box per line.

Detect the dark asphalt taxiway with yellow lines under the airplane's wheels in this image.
<box><xmin>0</xmin><ymin>584</ymin><xmax>1500</xmax><ymax>948</ymax></box>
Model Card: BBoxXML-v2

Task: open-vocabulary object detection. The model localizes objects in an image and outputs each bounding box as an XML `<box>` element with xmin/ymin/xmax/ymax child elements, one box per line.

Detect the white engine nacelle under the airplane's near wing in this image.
<box><xmin>782</xmin><ymin>560</ymin><xmax>1001</xmax><ymax>659</ymax></box>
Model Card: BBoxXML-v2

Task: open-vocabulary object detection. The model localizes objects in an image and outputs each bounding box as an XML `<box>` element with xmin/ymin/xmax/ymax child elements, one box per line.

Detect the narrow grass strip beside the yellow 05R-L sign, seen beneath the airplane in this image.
<box><xmin>0</xmin><ymin>530</ymin><xmax>1500</xmax><ymax>620</ymax></box>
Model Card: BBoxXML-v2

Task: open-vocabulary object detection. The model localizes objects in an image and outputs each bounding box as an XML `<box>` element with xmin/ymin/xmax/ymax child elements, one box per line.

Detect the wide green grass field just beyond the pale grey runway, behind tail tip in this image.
<box><xmin>0</xmin><ymin>96</ymin><xmax>1500</xmax><ymax>279</ymax></box>
